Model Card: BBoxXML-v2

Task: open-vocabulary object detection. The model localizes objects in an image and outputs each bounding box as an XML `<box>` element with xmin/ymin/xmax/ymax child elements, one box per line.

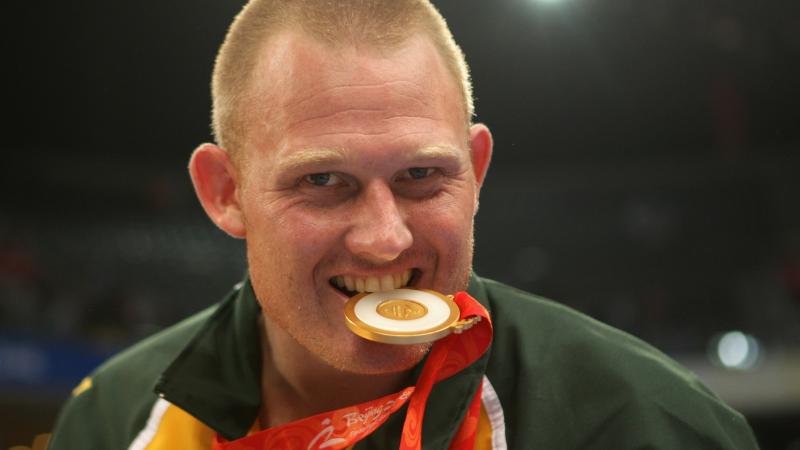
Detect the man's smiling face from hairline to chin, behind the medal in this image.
<box><xmin>237</xmin><ymin>33</ymin><xmax>488</xmax><ymax>374</ymax></box>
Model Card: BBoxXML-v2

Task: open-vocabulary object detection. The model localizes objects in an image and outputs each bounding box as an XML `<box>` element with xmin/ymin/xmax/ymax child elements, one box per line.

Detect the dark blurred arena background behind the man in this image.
<box><xmin>0</xmin><ymin>0</ymin><xmax>800</xmax><ymax>450</ymax></box>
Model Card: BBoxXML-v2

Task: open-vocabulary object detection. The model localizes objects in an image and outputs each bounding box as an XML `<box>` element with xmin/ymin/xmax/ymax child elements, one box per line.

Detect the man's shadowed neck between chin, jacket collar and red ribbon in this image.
<box><xmin>259</xmin><ymin>314</ymin><xmax>410</xmax><ymax>429</ymax></box>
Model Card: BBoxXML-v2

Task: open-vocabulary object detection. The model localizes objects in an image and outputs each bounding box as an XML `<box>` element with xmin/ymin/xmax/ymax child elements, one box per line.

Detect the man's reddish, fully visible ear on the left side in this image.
<box><xmin>189</xmin><ymin>144</ymin><xmax>246</xmax><ymax>238</ymax></box>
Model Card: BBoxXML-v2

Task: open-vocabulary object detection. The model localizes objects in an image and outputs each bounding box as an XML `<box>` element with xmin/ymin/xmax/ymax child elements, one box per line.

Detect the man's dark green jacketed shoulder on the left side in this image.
<box><xmin>50</xmin><ymin>305</ymin><xmax>217</xmax><ymax>449</ymax></box>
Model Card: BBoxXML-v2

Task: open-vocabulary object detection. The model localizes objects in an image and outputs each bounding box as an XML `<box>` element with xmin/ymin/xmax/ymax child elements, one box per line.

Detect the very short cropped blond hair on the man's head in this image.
<box><xmin>211</xmin><ymin>0</ymin><xmax>474</xmax><ymax>159</ymax></box>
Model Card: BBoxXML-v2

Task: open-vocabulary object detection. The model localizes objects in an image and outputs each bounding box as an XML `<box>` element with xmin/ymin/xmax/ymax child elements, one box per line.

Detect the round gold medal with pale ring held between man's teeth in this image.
<box><xmin>344</xmin><ymin>288</ymin><xmax>472</xmax><ymax>345</ymax></box>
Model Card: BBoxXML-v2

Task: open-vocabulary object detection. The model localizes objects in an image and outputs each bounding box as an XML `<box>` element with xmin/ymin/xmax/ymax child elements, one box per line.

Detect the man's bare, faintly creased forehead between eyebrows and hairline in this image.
<box><xmin>242</xmin><ymin>32</ymin><xmax>467</xmax><ymax>163</ymax></box>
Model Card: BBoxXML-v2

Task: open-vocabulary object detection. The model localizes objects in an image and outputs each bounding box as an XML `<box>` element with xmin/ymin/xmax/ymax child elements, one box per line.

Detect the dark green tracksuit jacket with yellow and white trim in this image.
<box><xmin>50</xmin><ymin>276</ymin><xmax>757</xmax><ymax>450</ymax></box>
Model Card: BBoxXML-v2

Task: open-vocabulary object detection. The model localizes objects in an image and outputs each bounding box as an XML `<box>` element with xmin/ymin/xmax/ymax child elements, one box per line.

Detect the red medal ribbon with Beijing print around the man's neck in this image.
<box><xmin>212</xmin><ymin>292</ymin><xmax>492</xmax><ymax>450</ymax></box>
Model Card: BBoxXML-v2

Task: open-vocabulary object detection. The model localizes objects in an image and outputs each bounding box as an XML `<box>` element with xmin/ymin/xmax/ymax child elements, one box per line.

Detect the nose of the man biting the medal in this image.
<box><xmin>345</xmin><ymin>181</ymin><xmax>414</xmax><ymax>263</ymax></box>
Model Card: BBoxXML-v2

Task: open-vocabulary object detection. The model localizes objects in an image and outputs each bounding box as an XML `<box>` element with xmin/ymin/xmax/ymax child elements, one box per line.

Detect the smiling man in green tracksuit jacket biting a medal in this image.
<box><xmin>51</xmin><ymin>0</ymin><xmax>755</xmax><ymax>449</ymax></box>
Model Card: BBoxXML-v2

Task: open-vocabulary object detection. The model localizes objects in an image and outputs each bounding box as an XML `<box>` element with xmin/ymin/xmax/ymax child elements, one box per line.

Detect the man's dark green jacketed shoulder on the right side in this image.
<box><xmin>480</xmin><ymin>279</ymin><xmax>756</xmax><ymax>449</ymax></box>
